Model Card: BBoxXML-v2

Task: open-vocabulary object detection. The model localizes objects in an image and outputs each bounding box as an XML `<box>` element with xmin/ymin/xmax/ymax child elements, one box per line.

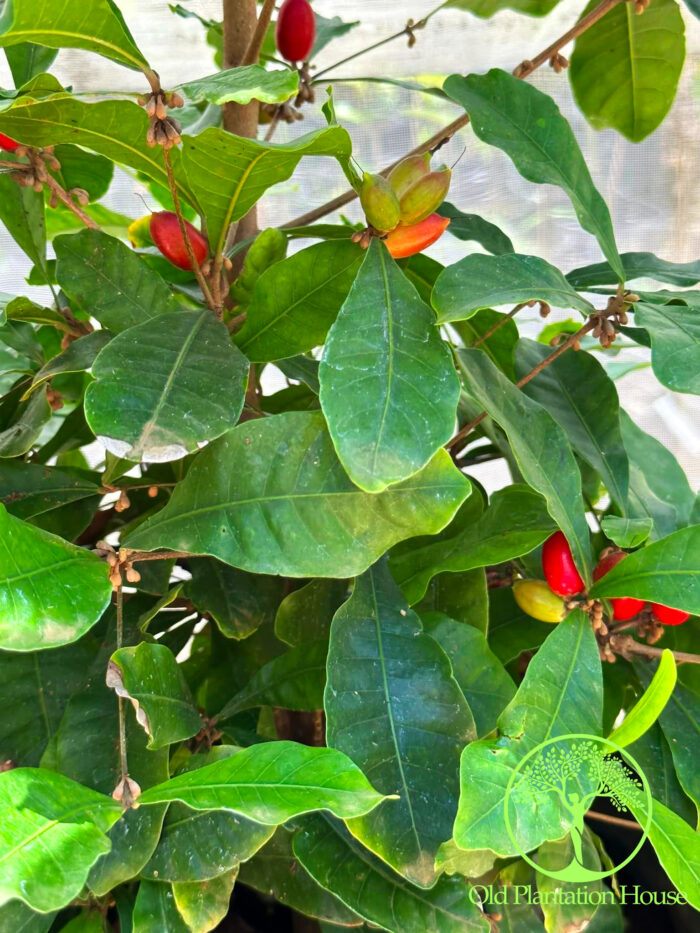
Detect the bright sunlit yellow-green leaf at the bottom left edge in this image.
<box><xmin>0</xmin><ymin>768</ymin><xmax>121</xmax><ymax>912</ymax></box>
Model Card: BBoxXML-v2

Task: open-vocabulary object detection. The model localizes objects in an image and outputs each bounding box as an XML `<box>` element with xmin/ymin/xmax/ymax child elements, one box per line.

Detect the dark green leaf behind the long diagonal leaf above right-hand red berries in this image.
<box><xmin>515</xmin><ymin>340</ymin><xmax>629</xmax><ymax>511</ymax></box>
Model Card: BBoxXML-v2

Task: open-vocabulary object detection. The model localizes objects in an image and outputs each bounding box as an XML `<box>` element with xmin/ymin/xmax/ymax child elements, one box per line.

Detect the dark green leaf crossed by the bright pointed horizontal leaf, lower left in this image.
<box><xmin>141</xmin><ymin>745</ymin><xmax>274</xmax><ymax>884</ymax></box>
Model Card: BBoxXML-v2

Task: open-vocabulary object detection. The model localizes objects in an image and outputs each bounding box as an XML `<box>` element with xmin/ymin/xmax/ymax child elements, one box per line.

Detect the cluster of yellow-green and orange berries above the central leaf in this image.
<box><xmin>358</xmin><ymin>152</ymin><xmax>452</xmax><ymax>259</ymax></box>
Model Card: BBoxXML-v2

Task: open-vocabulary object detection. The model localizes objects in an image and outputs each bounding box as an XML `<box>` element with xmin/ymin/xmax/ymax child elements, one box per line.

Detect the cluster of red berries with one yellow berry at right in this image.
<box><xmin>513</xmin><ymin>531</ymin><xmax>689</xmax><ymax>625</ymax></box>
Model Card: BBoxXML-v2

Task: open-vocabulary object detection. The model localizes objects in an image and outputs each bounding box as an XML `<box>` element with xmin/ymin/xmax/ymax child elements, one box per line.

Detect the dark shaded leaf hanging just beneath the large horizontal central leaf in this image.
<box><xmin>187</xmin><ymin>557</ymin><xmax>284</xmax><ymax>639</ymax></box>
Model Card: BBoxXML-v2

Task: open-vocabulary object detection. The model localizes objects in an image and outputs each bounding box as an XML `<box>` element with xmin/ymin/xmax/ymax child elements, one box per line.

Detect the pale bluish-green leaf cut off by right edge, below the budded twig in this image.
<box><xmin>634</xmin><ymin>302</ymin><xmax>700</xmax><ymax>395</ymax></box>
